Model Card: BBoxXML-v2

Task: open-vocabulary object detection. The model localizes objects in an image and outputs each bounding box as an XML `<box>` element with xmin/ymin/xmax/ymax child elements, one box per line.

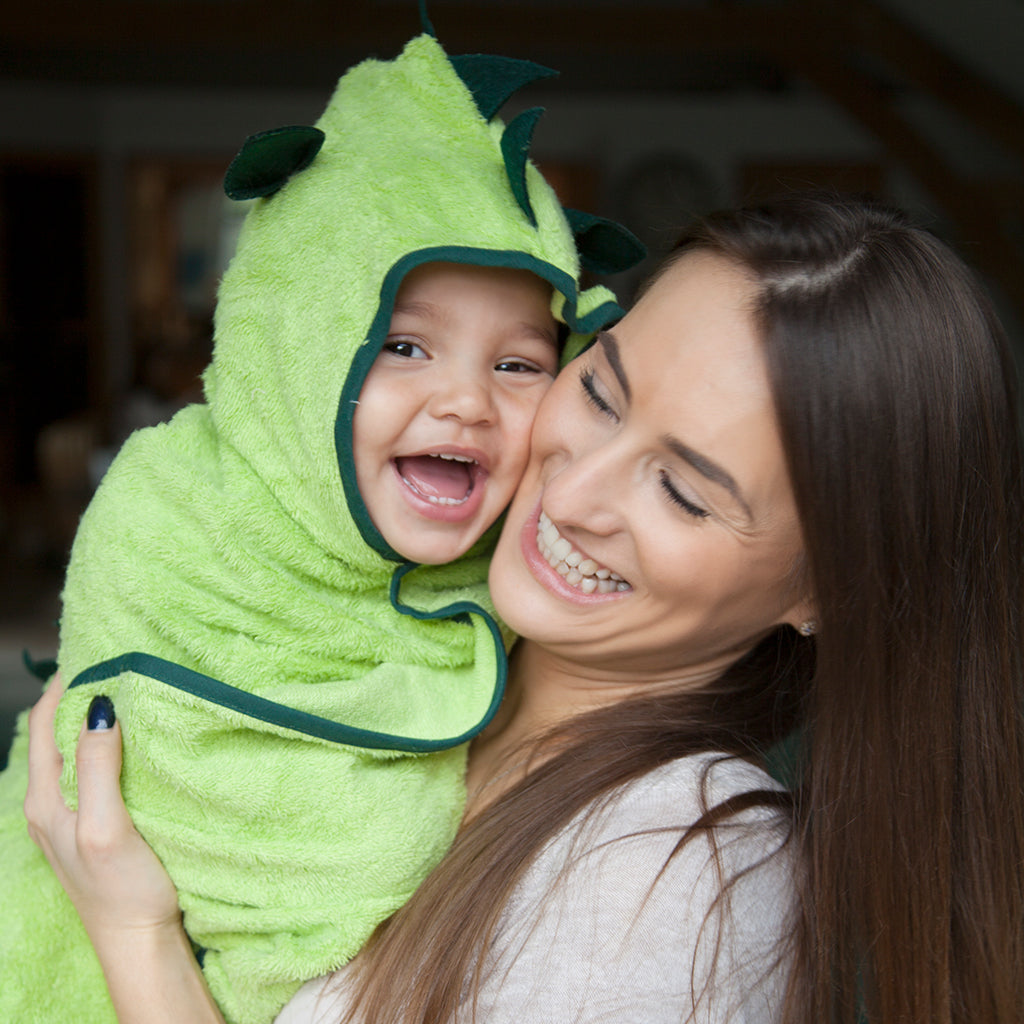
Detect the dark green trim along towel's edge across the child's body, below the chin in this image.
<box><xmin>61</xmin><ymin>638</ymin><xmax>507</xmax><ymax>754</ymax></box>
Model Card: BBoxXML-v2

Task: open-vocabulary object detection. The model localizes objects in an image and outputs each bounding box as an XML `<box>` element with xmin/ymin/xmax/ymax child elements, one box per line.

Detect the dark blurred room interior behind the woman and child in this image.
<box><xmin>0</xmin><ymin>0</ymin><xmax>1024</xmax><ymax>764</ymax></box>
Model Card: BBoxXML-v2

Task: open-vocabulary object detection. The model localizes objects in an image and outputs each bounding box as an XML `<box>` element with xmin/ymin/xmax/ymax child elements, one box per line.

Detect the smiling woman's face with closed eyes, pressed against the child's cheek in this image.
<box><xmin>490</xmin><ymin>253</ymin><xmax>811</xmax><ymax>681</ymax></box>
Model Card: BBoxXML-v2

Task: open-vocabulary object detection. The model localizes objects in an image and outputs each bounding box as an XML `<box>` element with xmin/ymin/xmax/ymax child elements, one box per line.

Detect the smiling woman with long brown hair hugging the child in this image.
<box><xmin>27</xmin><ymin>198</ymin><xmax>1024</xmax><ymax>1024</ymax></box>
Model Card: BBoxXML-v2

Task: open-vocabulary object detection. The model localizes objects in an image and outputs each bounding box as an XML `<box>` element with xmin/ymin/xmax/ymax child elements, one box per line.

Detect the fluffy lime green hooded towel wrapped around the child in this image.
<box><xmin>0</xmin><ymin>29</ymin><xmax>622</xmax><ymax>1024</ymax></box>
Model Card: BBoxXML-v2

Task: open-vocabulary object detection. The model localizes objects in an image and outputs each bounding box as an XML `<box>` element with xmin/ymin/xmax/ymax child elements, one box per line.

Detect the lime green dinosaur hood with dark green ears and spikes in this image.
<box><xmin>206</xmin><ymin>35</ymin><xmax>639</xmax><ymax>573</ymax></box>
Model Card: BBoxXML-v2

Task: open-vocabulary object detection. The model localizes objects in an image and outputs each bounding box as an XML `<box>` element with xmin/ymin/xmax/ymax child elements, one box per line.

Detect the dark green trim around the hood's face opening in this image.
<box><xmin>334</xmin><ymin>246</ymin><xmax>624</xmax><ymax>562</ymax></box>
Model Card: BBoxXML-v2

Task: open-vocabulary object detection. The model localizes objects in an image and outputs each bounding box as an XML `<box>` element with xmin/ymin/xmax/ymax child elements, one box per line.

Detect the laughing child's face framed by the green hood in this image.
<box><xmin>352</xmin><ymin>263</ymin><xmax>558</xmax><ymax>564</ymax></box>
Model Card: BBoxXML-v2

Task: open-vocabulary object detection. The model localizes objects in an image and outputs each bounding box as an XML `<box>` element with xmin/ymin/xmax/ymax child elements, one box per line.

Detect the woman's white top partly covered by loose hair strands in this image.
<box><xmin>275</xmin><ymin>755</ymin><xmax>794</xmax><ymax>1024</ymax></box>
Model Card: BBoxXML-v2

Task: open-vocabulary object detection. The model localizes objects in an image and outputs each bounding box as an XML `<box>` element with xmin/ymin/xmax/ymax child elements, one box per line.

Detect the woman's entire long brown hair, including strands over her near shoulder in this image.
<box><xmin>339</xmin><ymin>198</ymin><xmax>1024</xmax><ymax>1024</ymax></box>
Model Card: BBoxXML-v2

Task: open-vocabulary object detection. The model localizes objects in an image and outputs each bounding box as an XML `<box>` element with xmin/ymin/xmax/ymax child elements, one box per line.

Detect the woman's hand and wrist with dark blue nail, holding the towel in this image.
<box><xmin>25</xmin><ymin>678</ymin><xmax>223</xmax><ymax>1024</ymax></box>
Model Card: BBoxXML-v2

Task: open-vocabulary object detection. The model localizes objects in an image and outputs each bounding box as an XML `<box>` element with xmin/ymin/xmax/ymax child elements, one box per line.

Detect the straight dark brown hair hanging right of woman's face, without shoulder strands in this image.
<box><xmin>686</xmin><ymin>197</ymin><xmax>1024</xmax><ymax>1024</ymax></box>
